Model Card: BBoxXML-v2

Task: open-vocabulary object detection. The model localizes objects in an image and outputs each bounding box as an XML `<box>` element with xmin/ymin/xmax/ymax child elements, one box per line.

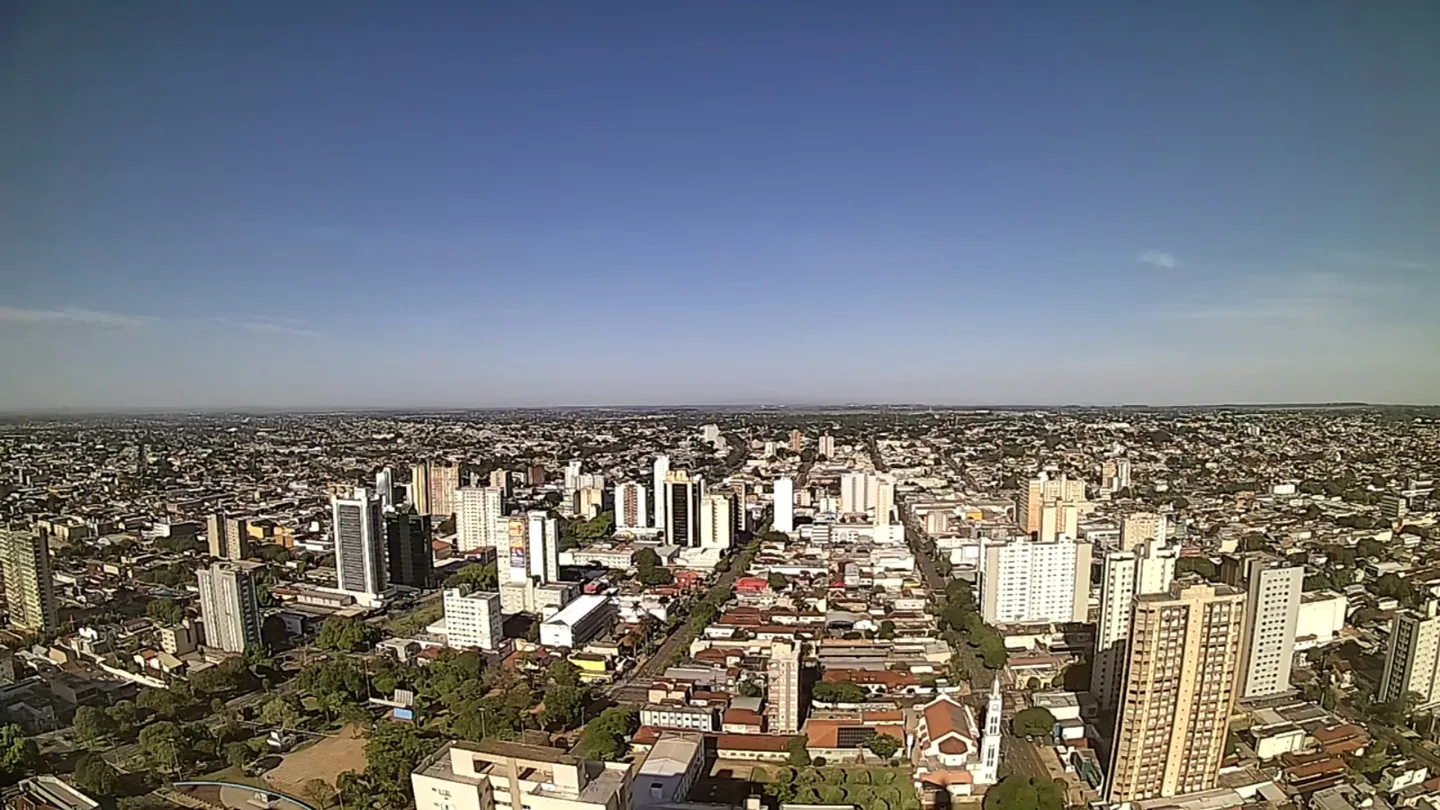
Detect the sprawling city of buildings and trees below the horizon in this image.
<box><xmin>0</xmin><ymin>406</ymin><xmax>1440</xmax><ymax>810</ymax></box>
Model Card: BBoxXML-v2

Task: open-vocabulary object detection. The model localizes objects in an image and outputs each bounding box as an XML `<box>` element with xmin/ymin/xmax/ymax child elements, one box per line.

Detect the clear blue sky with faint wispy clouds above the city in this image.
<box><xmin>0</xmin><ymin>0</ymin><xmax>1440</xmax><ymax>409</ymax></box>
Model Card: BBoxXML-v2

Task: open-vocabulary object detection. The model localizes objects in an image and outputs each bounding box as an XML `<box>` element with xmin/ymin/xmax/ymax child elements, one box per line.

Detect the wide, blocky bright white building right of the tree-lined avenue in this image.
<box><xmin>981</xmin><ymin>538</ymin><xmax>1090</xmax><ymax>624</ymax></box>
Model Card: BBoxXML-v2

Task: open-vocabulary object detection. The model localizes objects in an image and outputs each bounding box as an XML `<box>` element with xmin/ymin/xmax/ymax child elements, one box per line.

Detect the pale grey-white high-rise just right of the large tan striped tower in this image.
<box><xmin>1221</xmin><ymin>553</ymin><xmax>1305</xmax><ymax>700</ymax></box>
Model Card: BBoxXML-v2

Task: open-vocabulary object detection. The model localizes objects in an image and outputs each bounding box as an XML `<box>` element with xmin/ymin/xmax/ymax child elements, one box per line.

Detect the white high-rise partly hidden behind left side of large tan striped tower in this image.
<box><xmin>1090</xmin><ymin>540</ymin><xmax>1179</xmax><ymax>709</ymax></box>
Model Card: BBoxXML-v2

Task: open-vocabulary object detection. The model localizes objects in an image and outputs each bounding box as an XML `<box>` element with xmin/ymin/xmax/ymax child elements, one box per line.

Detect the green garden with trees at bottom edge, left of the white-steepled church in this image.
<box><xmin>693</xmin><ymin>761</ymin><xmax>920</xmax><ymax>810</ymax></box>
